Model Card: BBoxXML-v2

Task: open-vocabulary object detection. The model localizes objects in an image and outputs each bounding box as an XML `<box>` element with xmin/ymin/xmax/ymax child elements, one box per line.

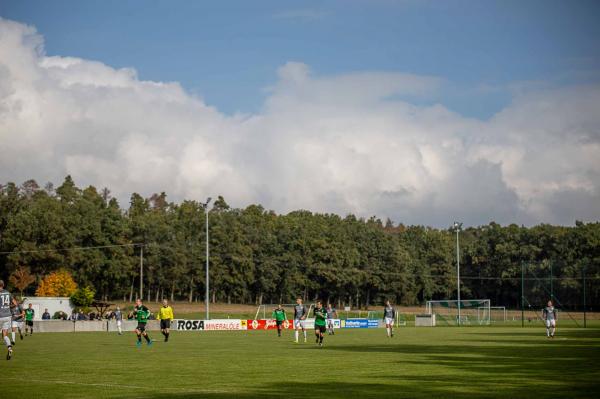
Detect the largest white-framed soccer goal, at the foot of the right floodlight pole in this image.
<box><xmin>425</xmin><ymin>299</ymin><xmax>491</xmax><ymax>326</ymax></box>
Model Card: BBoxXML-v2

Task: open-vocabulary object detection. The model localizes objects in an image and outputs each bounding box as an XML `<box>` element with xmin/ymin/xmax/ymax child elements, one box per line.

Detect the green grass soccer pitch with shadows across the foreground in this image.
<box><xmin>0</xmin><ymin>327</ymin><xmax>600</xmax><ymax>399</ymax></box>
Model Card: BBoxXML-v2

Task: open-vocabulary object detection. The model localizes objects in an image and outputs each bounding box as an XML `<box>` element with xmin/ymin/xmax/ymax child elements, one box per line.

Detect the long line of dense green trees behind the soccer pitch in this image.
<box><xmin>0</xmin><ymin>176</ymin><xmax>600</xmax><ymax>308</ymax></box>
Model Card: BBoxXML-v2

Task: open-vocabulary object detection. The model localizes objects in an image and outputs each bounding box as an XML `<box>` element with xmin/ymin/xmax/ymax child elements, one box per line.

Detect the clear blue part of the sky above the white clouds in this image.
<box><xmin>0</xmin><ymin>0</ymin><xmax>600</xmax><ymax>119</ymax></box>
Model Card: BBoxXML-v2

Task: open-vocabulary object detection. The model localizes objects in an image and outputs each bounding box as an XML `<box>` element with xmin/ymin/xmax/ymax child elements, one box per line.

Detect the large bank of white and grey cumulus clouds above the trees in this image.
<box><xmin>0</xmin><ymin>20</ymin><xmax>600</xmax><ymax>226</ymax></box>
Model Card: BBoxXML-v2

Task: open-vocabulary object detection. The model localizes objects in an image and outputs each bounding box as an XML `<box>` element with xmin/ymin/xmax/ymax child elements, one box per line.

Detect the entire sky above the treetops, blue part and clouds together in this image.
<box><xmin>0</xmin><ymin>0</ymin><xmax>600</xmax><ymax>227</ymax></box>
